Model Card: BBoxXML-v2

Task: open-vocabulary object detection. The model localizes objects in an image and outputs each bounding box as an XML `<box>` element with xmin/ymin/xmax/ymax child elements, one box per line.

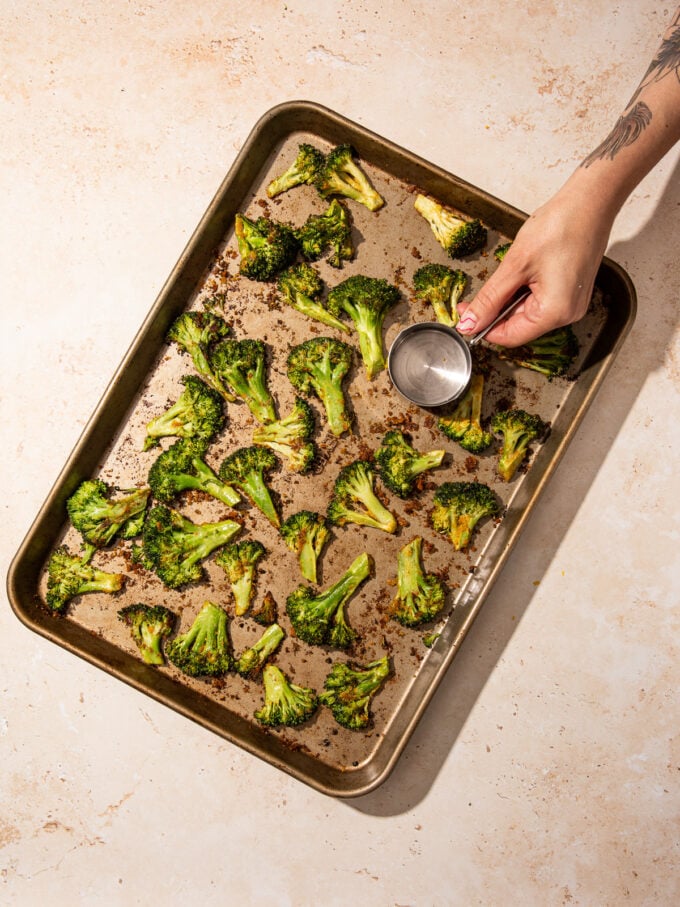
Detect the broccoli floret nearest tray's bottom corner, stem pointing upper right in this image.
<box><xmin>319</xmin><ymin>655</ymin><xmax>390</xmax><ymax>731</ymax></box>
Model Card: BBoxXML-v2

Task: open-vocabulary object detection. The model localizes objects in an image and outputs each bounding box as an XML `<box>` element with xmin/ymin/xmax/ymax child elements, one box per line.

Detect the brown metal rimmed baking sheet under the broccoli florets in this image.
<box><xmin>8</xmin><ymin>102</ymin><xmax>635</xmax><ymax>797</ymax></box>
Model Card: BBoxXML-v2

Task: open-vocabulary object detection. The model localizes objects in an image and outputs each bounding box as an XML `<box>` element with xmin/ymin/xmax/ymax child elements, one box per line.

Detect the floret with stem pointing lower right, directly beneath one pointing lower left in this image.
<box><xmin>148</xmin><ymin>438</ymin><xmax>241</xmax><ymax>507</ymax></box>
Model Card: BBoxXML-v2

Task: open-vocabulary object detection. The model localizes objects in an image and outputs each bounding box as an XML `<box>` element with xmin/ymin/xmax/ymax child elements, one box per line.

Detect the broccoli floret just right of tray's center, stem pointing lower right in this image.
<box><xmin>328</xmin><ymin>460</ymin><xmax>397</xmax><ymax>533</ymax></box>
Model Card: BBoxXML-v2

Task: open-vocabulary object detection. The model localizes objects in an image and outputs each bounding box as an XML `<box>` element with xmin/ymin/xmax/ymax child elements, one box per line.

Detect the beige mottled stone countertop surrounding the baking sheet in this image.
<box><xmin>0</xmin><ymin>0</ymin><xmax>680</xmax><ymax>907</ymax></box>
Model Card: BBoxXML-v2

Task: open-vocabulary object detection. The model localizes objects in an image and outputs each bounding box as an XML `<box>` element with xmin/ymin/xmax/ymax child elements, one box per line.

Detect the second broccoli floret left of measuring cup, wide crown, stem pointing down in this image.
<box><xmin>287</xmin><ymin>337</ymin><xmax>353</xmax><ymax>437</ymax></box>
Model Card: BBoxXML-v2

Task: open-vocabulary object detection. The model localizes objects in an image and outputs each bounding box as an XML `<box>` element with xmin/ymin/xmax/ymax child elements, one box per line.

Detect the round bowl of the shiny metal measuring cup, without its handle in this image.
<box><xmin>387</xmin><ymin>321</ymin><xmax>472</xmax><ymax>407</ymax></box>
